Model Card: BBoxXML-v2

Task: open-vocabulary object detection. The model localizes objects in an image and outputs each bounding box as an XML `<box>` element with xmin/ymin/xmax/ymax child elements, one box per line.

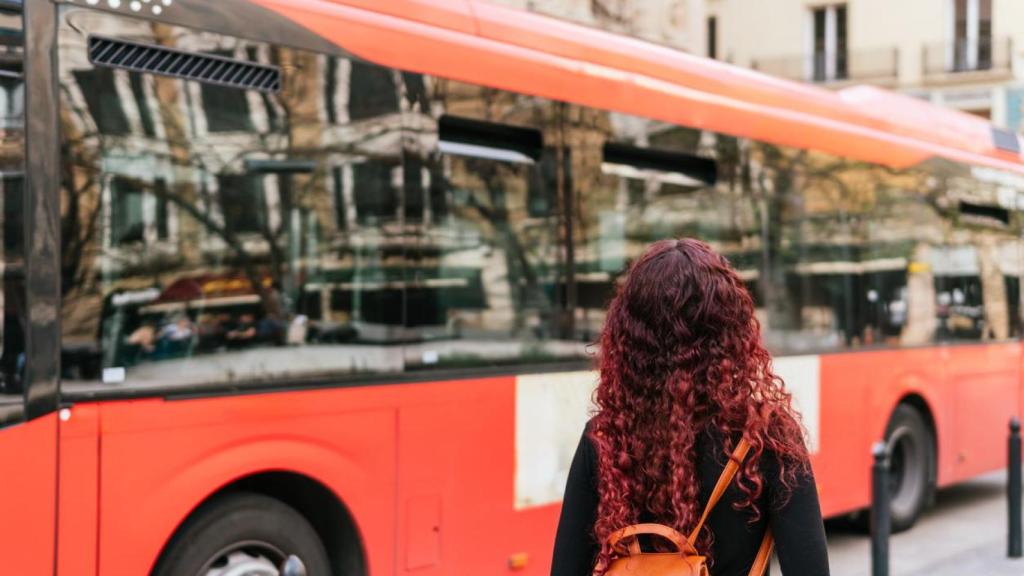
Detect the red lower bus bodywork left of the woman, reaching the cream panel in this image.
<box><xmin>64</xmin><ymin>376</ymin><xmax>558</xmax><ymax>576</ymax></box>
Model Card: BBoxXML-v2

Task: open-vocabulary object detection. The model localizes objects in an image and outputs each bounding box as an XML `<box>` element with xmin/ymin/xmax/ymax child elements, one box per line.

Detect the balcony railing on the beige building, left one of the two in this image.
<box><xmin>752</xmin><ymin>47</ymin><xmax>899</xmax><ymax>82</ymax></box>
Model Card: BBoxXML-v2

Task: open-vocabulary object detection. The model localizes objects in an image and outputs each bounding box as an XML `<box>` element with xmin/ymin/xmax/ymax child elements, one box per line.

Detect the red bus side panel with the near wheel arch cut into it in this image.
<box><xmin>99</xmin><ymin>386</ymin><xmax>400</xmax><ymax>576</ymax></box>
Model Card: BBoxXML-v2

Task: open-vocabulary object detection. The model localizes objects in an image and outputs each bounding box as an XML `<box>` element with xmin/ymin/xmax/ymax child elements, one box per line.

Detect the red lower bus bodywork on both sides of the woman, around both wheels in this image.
<box><xmin>51</xmin><ymin>343</ymin><xmax>1020</xmax><ymax>575</ymax></box>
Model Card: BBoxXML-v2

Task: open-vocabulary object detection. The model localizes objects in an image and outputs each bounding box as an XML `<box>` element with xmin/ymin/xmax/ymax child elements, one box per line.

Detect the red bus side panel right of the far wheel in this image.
<box><xmin>947</xmin><ymin>342</ymin><xmax>1020</xmax><ymax>482</ymax></box>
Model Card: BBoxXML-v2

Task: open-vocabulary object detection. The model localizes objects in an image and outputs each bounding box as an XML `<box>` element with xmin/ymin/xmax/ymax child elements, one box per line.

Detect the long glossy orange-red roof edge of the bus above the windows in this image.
<box><xmin>254</xmin><ymin>0</ymin><xmax>1024</xmax><ymax>173</ymax></box>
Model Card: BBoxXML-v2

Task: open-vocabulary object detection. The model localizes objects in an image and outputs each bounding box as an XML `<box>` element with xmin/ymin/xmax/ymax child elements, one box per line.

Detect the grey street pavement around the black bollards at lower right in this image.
<box><xmin>819</xmin><ymin>472</ymin><xmax>1024</xmax><ymax>576</ymax></box>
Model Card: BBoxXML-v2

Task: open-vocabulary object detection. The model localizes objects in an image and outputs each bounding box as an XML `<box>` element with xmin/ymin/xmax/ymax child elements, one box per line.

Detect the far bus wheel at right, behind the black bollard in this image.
<box><xmin>886</xmin><ymin>404</ymin><xmax>935</xmax><ymax>532</ymax></box>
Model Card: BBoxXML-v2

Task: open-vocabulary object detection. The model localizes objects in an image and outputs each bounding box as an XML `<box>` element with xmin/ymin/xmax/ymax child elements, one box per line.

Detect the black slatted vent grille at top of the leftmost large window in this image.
<box><xmin>89</xmin><ymin>36</ymin><xmax>281</xmax><ymax>92</ymax></box>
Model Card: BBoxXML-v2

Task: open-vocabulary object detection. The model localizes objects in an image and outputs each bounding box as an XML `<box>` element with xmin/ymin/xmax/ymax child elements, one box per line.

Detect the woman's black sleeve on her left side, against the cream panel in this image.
<box><xmin>551</xmin><ymin>433</ymin><xmax>598</xmax><ymax>576</ymax></box>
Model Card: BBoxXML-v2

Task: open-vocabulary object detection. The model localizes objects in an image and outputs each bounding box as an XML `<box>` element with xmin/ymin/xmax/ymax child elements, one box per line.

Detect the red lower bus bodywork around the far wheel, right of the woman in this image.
<box><xmin>813</xmin><ymin>342</ymin><xmax>1021</xmax><ymax>516</ymax></box>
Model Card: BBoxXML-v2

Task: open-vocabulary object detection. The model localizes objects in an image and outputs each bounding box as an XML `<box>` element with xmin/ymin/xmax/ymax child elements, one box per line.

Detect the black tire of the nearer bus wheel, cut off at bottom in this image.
<box><xmin>153</xmin><ymin>492</ymin><xmax>331</xmax><ymax>576</ymax></box>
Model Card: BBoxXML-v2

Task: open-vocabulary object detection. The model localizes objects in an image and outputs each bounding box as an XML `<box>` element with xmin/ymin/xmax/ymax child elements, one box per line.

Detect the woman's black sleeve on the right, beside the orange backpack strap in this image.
<box><xmin>765</xmin><ymin>455</ymin><xmax>828</xmax><ymax>576</ymax></box>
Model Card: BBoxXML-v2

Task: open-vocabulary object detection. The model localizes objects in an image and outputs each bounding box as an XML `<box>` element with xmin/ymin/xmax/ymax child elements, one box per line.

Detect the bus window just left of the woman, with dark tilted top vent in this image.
<box><xmin>403</xmin><ymin>74</ymin><xmax>587</xmax><ymax>369</ymax></box>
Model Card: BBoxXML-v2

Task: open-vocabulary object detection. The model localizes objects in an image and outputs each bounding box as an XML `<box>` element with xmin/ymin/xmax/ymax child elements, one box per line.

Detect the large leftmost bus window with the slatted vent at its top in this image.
<box><xmin>58</xmin><ymin>15</ymin><xmax>410</xmax><ymax>396</ymax></box>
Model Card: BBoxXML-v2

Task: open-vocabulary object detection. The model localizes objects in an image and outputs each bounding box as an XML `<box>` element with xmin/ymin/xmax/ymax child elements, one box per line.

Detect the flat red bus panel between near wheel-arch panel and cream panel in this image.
<box><xmin>397</xmin><ymin>376</ymin><xmax>520</xmax><ymax>576</ymax></box>
